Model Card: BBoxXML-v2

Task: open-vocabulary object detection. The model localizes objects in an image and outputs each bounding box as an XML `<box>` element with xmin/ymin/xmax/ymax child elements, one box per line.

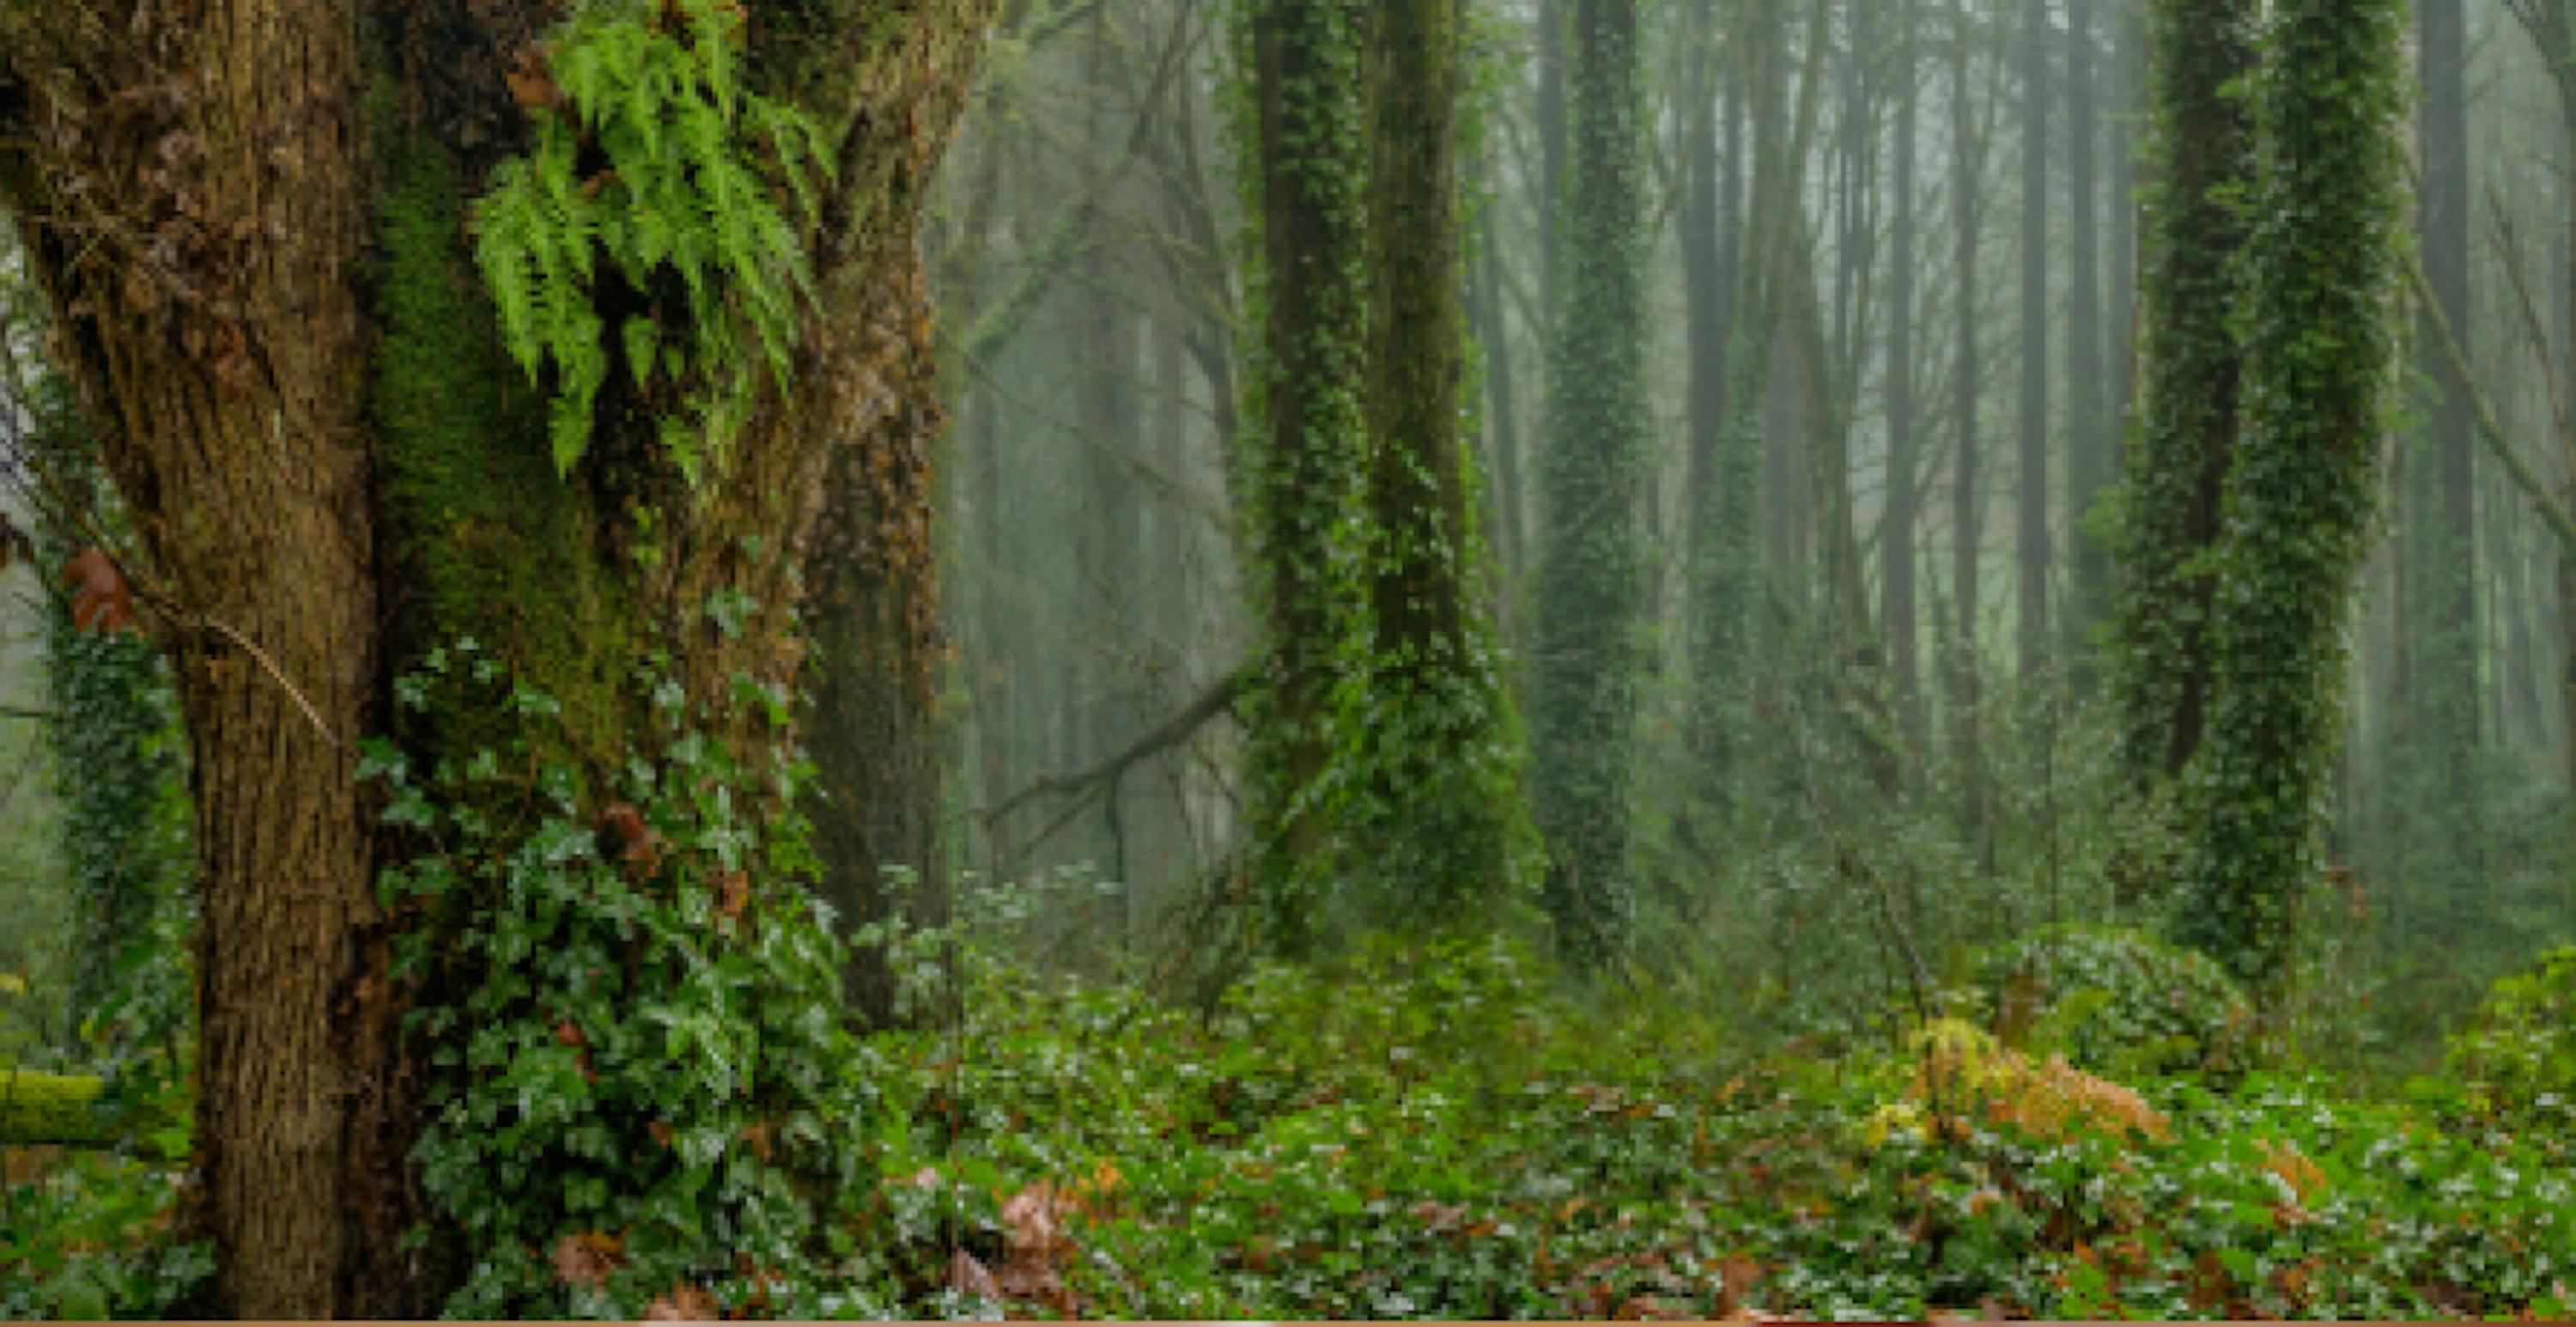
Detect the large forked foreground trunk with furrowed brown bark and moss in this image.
<box><xmin>0</xmin><ymin>0</ymin><xmax>989</xmax><ymax>1317</ymax></box>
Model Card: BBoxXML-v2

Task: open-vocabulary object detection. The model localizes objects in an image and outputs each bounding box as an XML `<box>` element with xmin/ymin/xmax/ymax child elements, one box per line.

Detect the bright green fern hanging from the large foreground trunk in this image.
<box><xmin>474</xmin><ymin>0</ymin><xmax>832</xmax><ymax>479</ymax></box>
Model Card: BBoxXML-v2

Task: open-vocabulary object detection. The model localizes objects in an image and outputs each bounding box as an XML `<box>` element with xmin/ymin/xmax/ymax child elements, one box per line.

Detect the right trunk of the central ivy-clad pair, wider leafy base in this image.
<box><xmin>1358</xmin><ymin>0</ymin><xmax>1533</xmax><ymax>925</ymax></box>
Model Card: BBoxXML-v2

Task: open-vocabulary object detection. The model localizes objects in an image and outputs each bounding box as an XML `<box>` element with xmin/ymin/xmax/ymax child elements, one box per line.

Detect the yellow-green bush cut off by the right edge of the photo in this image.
<box><xmin>2450</xmin><ymin>946</ymin><xmax>2576</xmax><ymax>1157</ymax></box>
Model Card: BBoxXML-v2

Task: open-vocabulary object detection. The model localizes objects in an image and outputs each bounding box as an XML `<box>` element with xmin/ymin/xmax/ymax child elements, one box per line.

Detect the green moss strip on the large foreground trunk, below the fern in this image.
<box><xmin>374</xmin><ymin>129</ymin><xmax>631</xmax><ymax>752</ymax></box>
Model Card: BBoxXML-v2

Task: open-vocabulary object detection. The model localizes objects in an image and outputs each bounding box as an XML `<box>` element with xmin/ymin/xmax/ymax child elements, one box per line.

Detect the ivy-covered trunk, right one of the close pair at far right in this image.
<box><xmin>2182</xmin><ymin>0</ymin><xmax>2406</xmax><ymax>1010</ymax></box>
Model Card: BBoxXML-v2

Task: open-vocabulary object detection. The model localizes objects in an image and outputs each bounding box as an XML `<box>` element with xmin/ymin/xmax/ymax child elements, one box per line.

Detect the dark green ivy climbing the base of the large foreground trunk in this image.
<box><xmin>363</xmin><ymin>642</ymin><xmax>889</xmax><ymax>1317</ymax></box>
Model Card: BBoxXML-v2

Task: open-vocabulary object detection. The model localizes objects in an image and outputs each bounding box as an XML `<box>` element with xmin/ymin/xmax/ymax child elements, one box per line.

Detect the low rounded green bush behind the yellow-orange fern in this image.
<box><xmin>1976</xmin><ymin>925</ymin><xmax>2254</xmax><ymax>1077</ymax></box>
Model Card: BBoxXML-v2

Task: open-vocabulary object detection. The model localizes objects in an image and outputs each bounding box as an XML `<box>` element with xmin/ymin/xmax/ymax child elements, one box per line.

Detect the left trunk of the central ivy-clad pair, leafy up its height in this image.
<box><xmin>1247</xmin><ymin>0</ymin><xmax>1368</xmax><ymax>953</ymax></box>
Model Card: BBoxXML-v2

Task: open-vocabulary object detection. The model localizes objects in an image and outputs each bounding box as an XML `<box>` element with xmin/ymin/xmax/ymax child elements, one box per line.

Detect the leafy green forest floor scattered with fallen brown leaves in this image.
<box><xmin>0</xmin><ymin>922</ymin><xmax>2576</xmax><ymax>1319</ymax></box>
